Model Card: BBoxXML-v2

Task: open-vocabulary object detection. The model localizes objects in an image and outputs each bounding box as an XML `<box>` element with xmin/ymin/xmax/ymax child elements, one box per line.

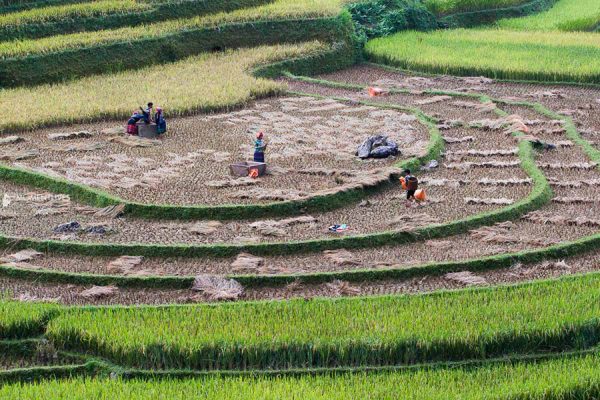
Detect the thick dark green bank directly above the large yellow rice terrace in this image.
<box><xmin>0</xmin><ymin>12</ymin><xmax>354</xmax><ymax>87</ymax></box>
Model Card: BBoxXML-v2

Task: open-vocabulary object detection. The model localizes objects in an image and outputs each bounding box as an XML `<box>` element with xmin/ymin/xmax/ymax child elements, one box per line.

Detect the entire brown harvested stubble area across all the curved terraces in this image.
<box><xmin>0</xmin><ymin>65</ymin><xmax>600</xmax><ymax>304</ymax></box>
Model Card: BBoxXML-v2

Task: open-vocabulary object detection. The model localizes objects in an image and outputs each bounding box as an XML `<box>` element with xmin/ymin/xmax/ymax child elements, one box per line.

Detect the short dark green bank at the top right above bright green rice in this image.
<box><xmin>438</xmin><ymin>0</ymin><xmax>558</xmax><ymax>28</ymax></box>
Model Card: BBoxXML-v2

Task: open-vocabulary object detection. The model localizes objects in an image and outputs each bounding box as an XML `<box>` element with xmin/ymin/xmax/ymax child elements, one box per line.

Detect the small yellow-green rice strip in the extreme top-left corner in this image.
<box><xmin>0</xmin><ymin>0</ymin><xmax>151</xmax><ymax>28</ymax></box>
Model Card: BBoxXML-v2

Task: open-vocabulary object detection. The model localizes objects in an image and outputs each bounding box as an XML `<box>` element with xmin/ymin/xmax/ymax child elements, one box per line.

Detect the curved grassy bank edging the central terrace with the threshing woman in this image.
<box><xmin>0</xmin><ymin>96</ymin><xmax>444</xmax><ymax>220</ymax></box>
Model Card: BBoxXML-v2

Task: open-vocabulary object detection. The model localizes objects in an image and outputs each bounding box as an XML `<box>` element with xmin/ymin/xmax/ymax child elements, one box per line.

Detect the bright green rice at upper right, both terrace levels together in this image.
<box><xmin>367</xmin><ymin>0</ymin><xmax>600</xmax><ymax>84</ymax></box>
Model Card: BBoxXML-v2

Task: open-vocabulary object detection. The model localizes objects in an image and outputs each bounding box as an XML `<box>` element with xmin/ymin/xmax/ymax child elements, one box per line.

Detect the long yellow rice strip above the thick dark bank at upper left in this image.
<box><xmin>0</xmin><ymin>0</ymin><xmax>345</xmax><ymax>58</ymax></box>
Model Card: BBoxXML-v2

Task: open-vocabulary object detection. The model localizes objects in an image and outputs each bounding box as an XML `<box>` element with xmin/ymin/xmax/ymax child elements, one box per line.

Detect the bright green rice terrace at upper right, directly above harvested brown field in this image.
<box><xmin>366</xmin><ymin>29</ymin><xmax>600</xmax><ymax>83</ymax></box>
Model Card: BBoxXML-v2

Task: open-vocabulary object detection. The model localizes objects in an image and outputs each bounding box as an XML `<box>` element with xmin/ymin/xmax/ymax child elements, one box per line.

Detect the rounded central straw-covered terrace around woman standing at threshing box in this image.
<box><xmin>0</xmin><ymin>97</ymin><xmax>429</xmax><ymax>205</ymax></box>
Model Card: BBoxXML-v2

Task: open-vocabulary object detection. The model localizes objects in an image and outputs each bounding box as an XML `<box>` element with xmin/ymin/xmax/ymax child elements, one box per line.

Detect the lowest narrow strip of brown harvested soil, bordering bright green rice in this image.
<box><xmin>0</xmin><ymin>252</ymin><xmax>600</xmax><ymax>305</ymax></box>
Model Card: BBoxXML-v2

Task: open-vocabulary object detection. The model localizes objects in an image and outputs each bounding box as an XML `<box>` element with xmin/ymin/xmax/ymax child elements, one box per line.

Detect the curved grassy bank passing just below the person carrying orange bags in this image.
<box><xmin>0</xmin><ymin>87</ymin><xmax>553</xmax><ymax>257</ymax></box>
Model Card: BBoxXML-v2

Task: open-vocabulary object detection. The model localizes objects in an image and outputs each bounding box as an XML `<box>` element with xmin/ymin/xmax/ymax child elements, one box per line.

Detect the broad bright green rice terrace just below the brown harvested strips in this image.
<box><xmin>48</xmin><ymin>274</ymin><xmax>600</xmax><ymax>369</ymax></box>
